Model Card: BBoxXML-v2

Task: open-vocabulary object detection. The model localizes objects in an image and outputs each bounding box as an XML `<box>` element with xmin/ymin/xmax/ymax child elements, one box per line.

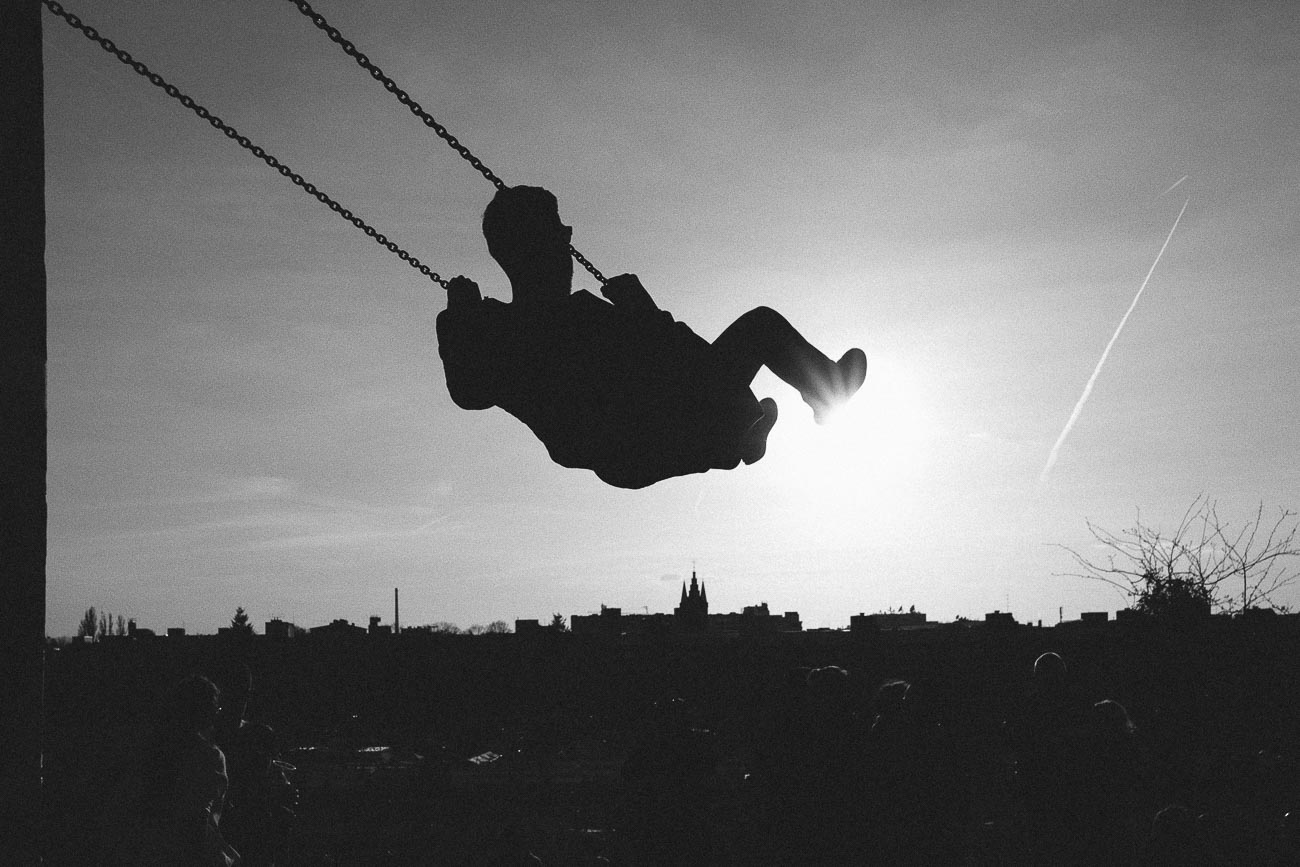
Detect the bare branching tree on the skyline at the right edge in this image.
<box><xmin>1061</xmin><ymin>495</ymin><xmax>1300</xmax><ymax>614</ymax></box>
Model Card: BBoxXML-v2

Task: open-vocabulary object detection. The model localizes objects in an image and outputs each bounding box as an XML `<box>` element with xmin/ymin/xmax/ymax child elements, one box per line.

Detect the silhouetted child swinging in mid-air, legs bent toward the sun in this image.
<box><xmin>437</xmin><ymin>186</ymin><xmax>867</xmax><ymax>489</ymax></box>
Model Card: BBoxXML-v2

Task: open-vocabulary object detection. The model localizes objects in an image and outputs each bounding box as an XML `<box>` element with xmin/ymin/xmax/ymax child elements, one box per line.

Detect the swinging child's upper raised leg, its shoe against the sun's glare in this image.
<box><xmin>712</xmin><ymin>307</ymin><xmax>866</xmax><ymax>421</ymax></box>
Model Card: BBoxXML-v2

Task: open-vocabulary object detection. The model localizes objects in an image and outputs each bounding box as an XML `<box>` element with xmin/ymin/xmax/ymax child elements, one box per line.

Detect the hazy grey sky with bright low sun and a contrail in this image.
<box><xmin>43</xmin><ymin>0</ymin><xmax>1300</xmax><ymax>634</ymax></box>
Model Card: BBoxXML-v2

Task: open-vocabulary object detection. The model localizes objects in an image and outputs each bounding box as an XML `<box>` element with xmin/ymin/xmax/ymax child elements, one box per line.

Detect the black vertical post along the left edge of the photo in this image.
<box><xmin>0</xmin><ymin>0</ymin><xmax>46</xmax><ymax>864</ymax></box>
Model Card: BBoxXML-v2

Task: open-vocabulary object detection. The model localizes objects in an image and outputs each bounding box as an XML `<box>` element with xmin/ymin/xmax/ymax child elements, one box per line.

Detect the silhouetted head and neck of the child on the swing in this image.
<box><xmin>484</xmin><ymin>187</ymin><xmax>573</xmax><ymax>300</ymax></box>
